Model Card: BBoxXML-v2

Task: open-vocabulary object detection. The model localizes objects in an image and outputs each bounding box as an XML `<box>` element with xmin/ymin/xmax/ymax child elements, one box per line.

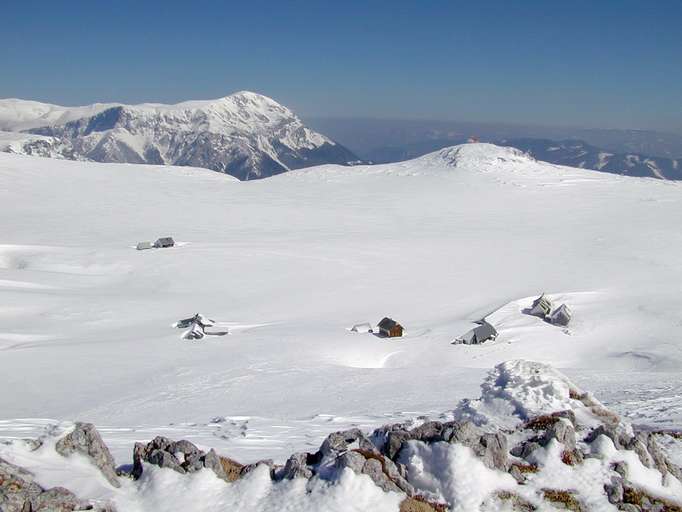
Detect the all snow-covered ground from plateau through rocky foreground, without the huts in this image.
<box><xmin>0</xmin><ymin>142</ymin><xmax>682</xmax><ymax>512</ymax></box>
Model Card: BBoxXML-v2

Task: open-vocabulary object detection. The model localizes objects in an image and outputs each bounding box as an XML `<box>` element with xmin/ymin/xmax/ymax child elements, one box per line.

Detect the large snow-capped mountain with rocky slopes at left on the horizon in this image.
<box><xmin>0</xmin><ymin>91</ymin><xmax>358</xmax><ymax>180</ymax></box>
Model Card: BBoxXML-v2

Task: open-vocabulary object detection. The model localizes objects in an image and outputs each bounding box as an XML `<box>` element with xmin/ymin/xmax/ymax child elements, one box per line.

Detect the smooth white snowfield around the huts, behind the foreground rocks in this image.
<box><xmin>0</xmin><ymin>144</ymin><xmax>682</xmax><ymax>508</ymax></box>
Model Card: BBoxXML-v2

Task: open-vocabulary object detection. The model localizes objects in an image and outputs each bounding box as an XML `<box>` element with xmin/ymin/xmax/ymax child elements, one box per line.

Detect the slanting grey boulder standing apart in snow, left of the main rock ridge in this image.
<box><xmin>55</xmin><ymin>422</ymin><xmax>121</xmax><ymax>487</ymax></box>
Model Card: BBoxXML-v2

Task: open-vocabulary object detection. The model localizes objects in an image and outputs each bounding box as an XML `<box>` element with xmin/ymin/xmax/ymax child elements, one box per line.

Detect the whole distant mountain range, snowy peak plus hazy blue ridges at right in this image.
<box><xmin>0</xmin><ymin>91</ymin><xmax>682</xmax><ymax>180</ymax></box>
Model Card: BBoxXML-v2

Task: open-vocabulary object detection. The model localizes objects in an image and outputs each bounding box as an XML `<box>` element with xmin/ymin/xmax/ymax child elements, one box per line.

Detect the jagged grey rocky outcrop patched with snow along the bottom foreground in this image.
<box><xmin>0</xmin><ymin>365</ymin><xmax>682</xmax><ymax>512</ymax></box>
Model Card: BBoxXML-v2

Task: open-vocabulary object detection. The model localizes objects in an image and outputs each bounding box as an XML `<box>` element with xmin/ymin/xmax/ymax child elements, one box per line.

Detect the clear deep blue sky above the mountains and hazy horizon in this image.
<box><xmin>0</xmin><ymin>0</ymin><xmax>682</xmax><ymax>132</ymax></box>
